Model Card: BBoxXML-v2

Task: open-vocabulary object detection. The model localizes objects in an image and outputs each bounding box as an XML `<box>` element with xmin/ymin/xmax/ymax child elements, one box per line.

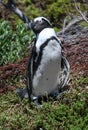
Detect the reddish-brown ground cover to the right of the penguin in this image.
<box><xmin>64</xmin><ymin>37</ymin><xmax>88</xmax><ymax>74</ymax></box>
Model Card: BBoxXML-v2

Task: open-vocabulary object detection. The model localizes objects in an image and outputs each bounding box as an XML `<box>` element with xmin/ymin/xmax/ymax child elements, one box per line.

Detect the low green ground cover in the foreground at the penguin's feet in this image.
<box><xmin>0</xmin><ymin>77</ymin><xmax>88</xmax><ymax>130</ymax></box>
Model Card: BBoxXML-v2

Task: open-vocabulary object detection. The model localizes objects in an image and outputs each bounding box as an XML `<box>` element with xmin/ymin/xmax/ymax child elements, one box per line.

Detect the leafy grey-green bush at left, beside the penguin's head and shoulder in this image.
<box><xmin>0</xmin><ymin>21</ymin><xmax>32</xmax><ymax>65</ymax></box>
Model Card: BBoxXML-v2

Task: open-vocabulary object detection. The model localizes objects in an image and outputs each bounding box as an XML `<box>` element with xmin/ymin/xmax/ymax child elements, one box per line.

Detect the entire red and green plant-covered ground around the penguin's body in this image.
<box><xmin>0</xmin><ymin>26</ymin><xmax>88</xmax><ymax>130</ymax></box>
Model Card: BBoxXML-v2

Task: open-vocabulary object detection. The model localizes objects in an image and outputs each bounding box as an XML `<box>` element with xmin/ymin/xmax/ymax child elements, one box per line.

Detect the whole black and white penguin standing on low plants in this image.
<box><xmin>17</xmin><ymin>17</ymin><xmax>69</xmax><ymax>101</ymax></box>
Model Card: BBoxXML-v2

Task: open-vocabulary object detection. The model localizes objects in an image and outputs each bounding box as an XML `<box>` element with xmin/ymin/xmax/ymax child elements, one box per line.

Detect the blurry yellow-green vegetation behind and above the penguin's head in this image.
<box><xmin>15</xmin><ymin>0</ymin><xmax>88</xmax><ymax>29</ymax></box>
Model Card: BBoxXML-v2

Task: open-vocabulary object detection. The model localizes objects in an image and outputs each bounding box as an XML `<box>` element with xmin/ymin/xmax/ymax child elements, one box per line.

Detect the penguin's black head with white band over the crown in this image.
<box><xmin>31</xmin><ymin>17</ymin><xmax>52</xmax><ymax>34</ymax></box>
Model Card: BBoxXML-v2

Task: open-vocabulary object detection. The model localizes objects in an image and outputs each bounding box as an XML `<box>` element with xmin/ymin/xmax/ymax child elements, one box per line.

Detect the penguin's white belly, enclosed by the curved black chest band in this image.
<box><xmin>33</xmin><ymin>40</ymin><xmax>61</xmax><ymax>96</ymax></box>
